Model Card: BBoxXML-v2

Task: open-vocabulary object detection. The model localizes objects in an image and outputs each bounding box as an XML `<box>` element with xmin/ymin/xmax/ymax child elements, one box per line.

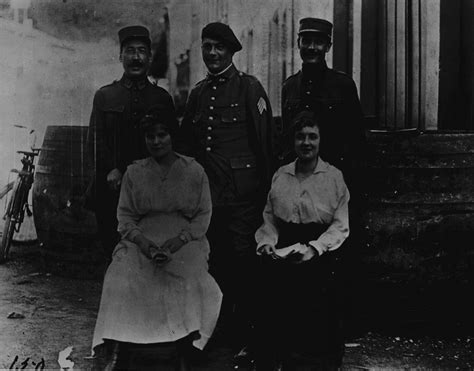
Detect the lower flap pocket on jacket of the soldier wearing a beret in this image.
<box><xmin>230</xmin><ymin>157</ymin><xmax>260</xmax><ymax>199</ymax></box>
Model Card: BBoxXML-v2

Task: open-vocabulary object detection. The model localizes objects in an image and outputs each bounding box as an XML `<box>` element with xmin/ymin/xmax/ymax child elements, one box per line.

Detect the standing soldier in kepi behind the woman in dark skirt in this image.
<box><xmin>279</xmin><ymin>18</ymin><xmax>365</xmax><ymax>370</ymax></box>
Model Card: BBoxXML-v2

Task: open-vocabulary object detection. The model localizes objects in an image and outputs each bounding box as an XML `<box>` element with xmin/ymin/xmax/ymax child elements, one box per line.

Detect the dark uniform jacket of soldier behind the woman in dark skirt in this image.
<box><xmin>279</xmin><ymin>62</ymin><xmax>365</xmax><ymax>175</ymax></box>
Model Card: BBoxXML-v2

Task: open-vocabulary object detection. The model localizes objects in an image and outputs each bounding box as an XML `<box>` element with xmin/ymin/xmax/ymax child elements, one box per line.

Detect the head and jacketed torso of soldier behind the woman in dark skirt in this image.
<box><xmin>279</xmin><ymin>18</ymin><xmax>365</xmax><ymax>176</ymax></box>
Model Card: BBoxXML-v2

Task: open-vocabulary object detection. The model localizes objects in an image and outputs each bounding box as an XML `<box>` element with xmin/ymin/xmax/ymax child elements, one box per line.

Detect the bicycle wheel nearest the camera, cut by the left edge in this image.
<box><xmin>0</xmin><ymin>179</ymin><xmax>25</xmax><ymax>263</ymax></box>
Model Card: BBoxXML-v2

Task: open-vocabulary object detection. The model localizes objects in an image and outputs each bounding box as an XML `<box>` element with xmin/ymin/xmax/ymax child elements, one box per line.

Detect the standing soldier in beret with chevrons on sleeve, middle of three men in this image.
<box><xmin>178</xmin><ymin>22</ymin><xmax>273</xmax><ymax>366</ymax></box>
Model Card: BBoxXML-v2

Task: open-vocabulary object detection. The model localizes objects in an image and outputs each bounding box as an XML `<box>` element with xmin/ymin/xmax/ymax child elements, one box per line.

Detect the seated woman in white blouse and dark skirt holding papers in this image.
<box><xmin>255</xmin><ymin>112</ymin><xmax>349</xmax><ymax>371</ymax></box>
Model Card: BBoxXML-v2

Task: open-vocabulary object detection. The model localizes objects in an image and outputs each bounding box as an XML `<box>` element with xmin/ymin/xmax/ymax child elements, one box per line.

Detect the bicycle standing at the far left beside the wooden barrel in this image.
<box><xmin>0</xmin><ymin>144</ymin><xmax>41</xmax><ymax>263</ymax></box>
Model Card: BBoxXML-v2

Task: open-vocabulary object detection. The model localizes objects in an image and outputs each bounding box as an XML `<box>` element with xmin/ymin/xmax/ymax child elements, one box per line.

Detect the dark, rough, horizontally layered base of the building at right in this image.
<box><xmin>360</xmin><ymin>132</ymin><xmax>474</xmax><ymax>332</ymax></box>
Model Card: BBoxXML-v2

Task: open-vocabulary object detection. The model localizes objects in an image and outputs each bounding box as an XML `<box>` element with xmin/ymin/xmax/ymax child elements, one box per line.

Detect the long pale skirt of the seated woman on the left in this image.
<box><xmin>92</xmin><ymin>239</ymin><xmax>222</xmax><ymax>349</ymax></box>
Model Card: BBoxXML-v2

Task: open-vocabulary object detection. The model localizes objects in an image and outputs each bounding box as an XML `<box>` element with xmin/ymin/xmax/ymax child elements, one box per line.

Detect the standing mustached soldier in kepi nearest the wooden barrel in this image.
<box><xmin>88</xmin><ymin>26</ymin><xmax>174</xmax><ymax>262</ymax></box>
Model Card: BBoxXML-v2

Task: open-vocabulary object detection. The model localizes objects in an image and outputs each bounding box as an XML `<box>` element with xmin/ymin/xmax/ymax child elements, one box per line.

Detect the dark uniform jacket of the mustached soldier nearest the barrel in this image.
<box><xmin>88</xmin><ymin>75</ymin><xmax>174</xmax><ymax>184</ymax></box>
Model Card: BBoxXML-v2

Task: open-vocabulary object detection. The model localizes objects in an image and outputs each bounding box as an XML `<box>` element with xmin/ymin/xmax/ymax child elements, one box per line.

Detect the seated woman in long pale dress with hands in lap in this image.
<box><xmin>92</xmin><ymin>110</ymin><xmax>222</xmax><ymax>370</ymax></box>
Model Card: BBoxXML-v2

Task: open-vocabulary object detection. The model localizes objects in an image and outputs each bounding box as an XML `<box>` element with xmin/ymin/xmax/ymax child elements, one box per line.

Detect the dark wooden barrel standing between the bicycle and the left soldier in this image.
<box><xmin>33</xmin><ymin>126</ymin><xmax>104</xmax><ymax>278</ymax></box>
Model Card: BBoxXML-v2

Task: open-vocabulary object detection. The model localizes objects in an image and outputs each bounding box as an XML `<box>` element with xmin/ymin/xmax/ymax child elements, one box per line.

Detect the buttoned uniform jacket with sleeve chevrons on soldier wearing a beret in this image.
<box><xmin>177</xmin><ymin>65</ymin><xmax>273</xmax><ymax>206</ymax></box>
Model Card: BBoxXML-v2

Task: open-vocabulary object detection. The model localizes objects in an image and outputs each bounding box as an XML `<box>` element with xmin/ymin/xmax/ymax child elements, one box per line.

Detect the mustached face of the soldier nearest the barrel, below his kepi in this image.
<box><xmin>120</xmin><ymin>39</ymin><xmax>151</xmax><ymax>79</ymax></box>
